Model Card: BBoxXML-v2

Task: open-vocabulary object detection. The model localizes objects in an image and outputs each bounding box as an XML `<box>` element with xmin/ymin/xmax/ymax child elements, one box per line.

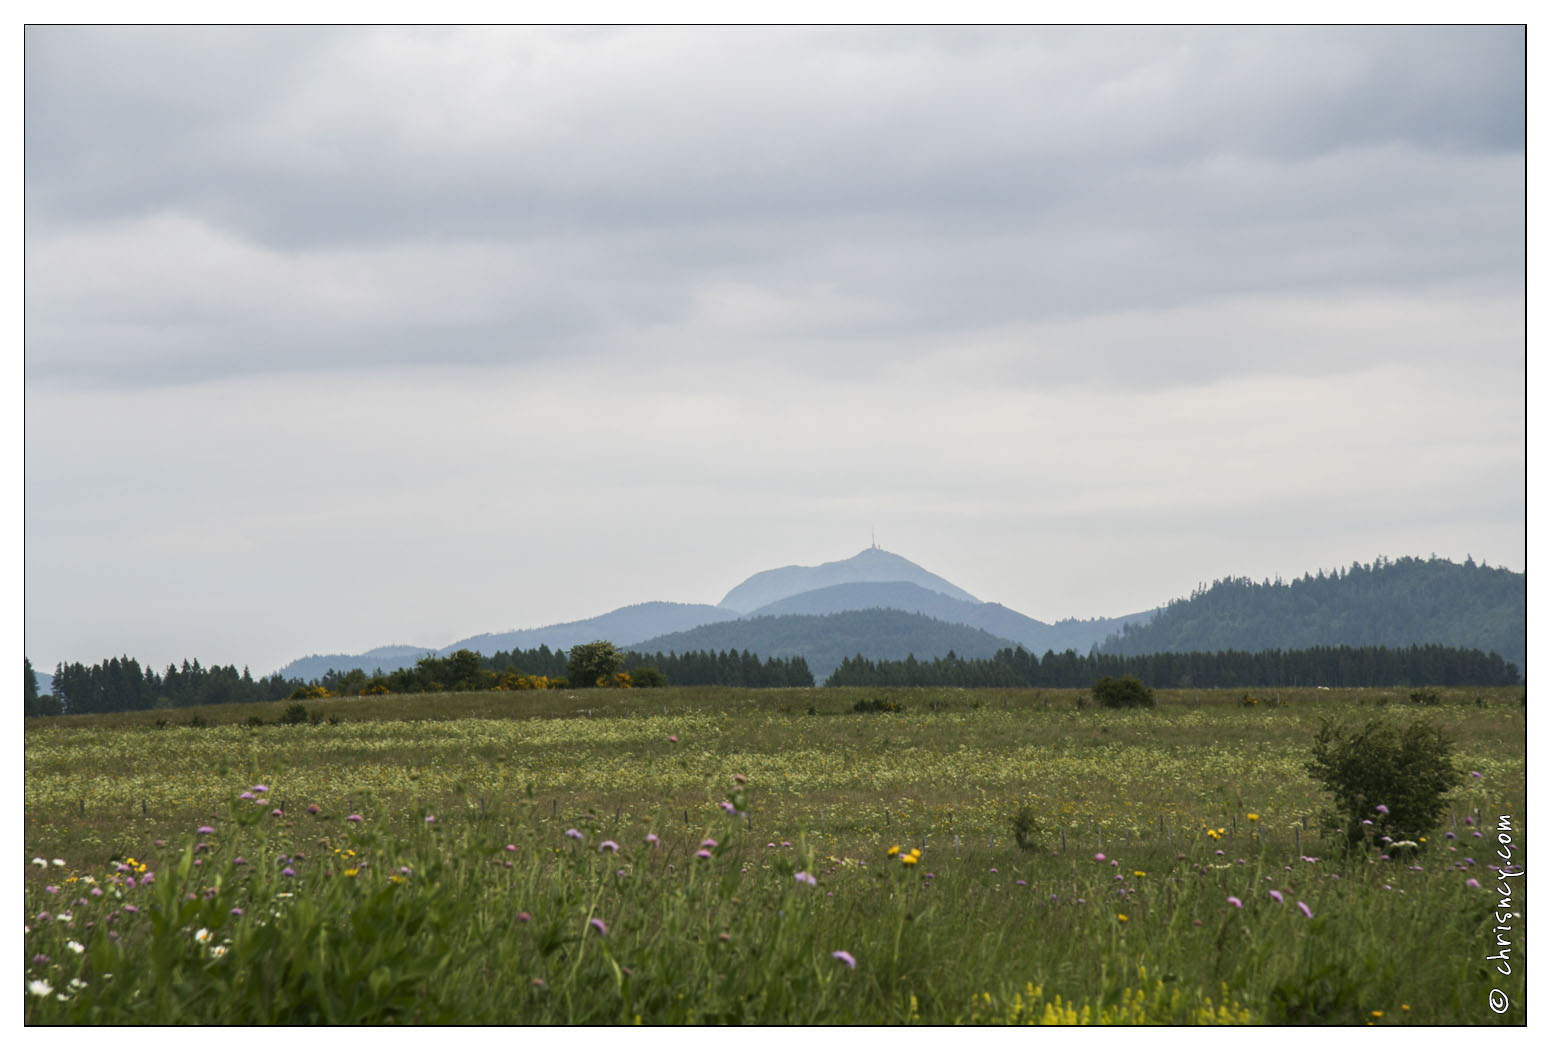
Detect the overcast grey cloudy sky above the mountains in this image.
<box><xmin>23</xmin><ymin>26</ymin><xmax>1526</xmax><ymax>674</ymax></box>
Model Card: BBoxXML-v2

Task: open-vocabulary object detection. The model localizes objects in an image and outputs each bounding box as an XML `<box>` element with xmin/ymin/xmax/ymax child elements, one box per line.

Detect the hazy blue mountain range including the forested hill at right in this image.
<box><xmin>281</xmin><ymin>547</ymin><xmax>1525</xmax><ymax>682</ymax></box>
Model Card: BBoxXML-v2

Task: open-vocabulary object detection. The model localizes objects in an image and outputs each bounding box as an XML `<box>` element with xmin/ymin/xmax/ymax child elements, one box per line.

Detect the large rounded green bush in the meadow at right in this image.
<box><xmin>1306</xmin><ymin>719</ymin><xmax>1461</xmax><ymax>848</ymax></box>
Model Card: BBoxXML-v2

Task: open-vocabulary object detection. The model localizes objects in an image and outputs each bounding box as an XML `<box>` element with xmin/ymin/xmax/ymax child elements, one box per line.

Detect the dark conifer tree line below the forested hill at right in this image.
<box><xmin>824</xmin><ymin>645</ymin><xmax>1523</xmax><ymax>690</ymax></box>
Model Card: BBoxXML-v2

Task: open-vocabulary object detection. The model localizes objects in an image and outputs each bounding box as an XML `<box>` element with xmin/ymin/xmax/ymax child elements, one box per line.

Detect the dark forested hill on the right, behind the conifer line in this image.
<box><xmin>1101</xmin><ymin>558</ymin><xmax>1526</xmax><ymax>671</ymax></box>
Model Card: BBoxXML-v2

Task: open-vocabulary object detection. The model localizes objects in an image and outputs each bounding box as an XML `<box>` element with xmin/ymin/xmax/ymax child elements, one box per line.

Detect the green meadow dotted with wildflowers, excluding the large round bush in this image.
<box><xmin>23</xmin><ymin>688</ymin><xmax>1526</xmax><ymax>1025</ymax></box>
